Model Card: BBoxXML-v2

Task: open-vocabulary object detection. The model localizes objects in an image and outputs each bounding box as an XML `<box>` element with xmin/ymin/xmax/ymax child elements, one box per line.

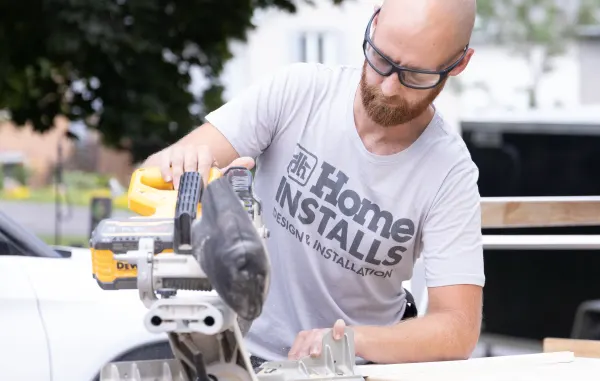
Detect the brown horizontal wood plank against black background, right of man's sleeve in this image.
<box><xmin>481</xmin><ymin>196</ymin><xmax>600</xmax><ymax>228</ymax></box>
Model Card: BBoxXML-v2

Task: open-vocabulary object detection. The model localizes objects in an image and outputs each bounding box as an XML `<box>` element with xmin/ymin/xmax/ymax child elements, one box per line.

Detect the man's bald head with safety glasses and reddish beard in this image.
<box><xmin>360</xmin><ymin>0</ymin><xmax>476</xmax><ymax>127</ymax></box>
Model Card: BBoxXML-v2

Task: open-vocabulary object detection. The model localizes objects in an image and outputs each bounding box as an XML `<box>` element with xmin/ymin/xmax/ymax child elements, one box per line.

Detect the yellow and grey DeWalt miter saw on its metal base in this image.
<box><xmin>90</xmin><ymin>167</ymin><xmax>363</xmax><ymax>381</ymax></box>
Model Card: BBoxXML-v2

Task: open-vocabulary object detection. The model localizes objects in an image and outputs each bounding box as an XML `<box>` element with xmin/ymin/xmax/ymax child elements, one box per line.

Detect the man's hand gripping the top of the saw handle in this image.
<box><xmin>142</xmin><ymin>123</ymin><xmax>254</xmax><ymax>190</ymax></box>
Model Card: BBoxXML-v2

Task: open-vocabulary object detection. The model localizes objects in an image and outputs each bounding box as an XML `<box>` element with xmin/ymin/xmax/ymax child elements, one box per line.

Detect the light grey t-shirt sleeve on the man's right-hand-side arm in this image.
<box><xmin>422</xmin><ymin>161</ymin><xmax>485</xmax><ymax>287</ymax></box>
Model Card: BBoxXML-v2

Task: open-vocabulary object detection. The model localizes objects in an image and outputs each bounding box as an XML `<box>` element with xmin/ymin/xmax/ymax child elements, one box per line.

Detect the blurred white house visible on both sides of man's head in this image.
<box><xmin>203</xmin><ymin>0</ymin><xmax>600</xmax><ymax>128</ymax></box>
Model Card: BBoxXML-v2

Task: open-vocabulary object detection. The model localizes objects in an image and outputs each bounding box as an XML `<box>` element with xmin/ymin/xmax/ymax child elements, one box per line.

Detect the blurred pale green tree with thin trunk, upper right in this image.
<box><xmin>477</xmin><ymin>0</ymin><xmax>600</xmax><ymax>108</ymax></box>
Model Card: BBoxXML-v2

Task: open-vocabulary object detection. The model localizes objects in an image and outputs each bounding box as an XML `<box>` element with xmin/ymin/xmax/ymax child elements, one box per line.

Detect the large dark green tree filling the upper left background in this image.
<box><xmin>0</xmin><ymin>0</ymin><xmax>343</xmax><ymax>160</ymax></box>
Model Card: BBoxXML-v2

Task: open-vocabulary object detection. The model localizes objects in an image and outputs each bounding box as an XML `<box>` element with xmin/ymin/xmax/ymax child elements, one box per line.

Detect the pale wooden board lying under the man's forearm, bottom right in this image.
<box><xmin>356</xmin><ymin>352</ymin><xmax>600</xmax><ymax>381</ymax></box>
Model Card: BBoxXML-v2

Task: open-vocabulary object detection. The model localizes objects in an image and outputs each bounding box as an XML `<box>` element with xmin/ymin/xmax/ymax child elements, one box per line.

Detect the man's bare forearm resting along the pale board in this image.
<box><xmin>352</xmin><ymin>312</ymin><xmax>480</xmax><ymax>364</ymax></box>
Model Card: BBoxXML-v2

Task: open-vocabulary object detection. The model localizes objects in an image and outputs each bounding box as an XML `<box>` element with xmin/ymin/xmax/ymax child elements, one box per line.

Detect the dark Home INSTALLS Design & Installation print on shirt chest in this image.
<box><xmin>273</xmin><ymin>144</ymin><xmax>415</xmax><ymax>278</ymax></box>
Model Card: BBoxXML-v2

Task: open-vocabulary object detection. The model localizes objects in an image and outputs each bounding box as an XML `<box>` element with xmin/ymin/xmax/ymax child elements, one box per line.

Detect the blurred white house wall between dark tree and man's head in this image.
<box><xmin>213</xmin><ymin>0</ymin><xmax>375</xmax><ymax>99</ymax></box>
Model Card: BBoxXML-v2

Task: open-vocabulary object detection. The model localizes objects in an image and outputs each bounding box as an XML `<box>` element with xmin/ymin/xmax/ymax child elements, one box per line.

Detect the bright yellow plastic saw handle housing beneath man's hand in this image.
<box><xmin>127</xmin><ymin>167</ymin><xmax>222</xmax><ymax>217</ymax></box>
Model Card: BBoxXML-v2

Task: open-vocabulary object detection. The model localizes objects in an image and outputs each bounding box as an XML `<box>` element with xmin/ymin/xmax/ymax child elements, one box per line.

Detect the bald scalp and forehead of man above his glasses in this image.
<box><xmin>374</xmin><ymin>0</ymin><xmax>476</xmax><ymax>69</ymax></box>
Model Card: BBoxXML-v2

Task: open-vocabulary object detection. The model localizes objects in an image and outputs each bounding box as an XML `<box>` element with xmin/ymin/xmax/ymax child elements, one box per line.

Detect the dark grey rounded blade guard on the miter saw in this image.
<box><xmin>192</xmin><ymin>174</ymin><xmax>270</xmax><ymax>320</ymax></box>
